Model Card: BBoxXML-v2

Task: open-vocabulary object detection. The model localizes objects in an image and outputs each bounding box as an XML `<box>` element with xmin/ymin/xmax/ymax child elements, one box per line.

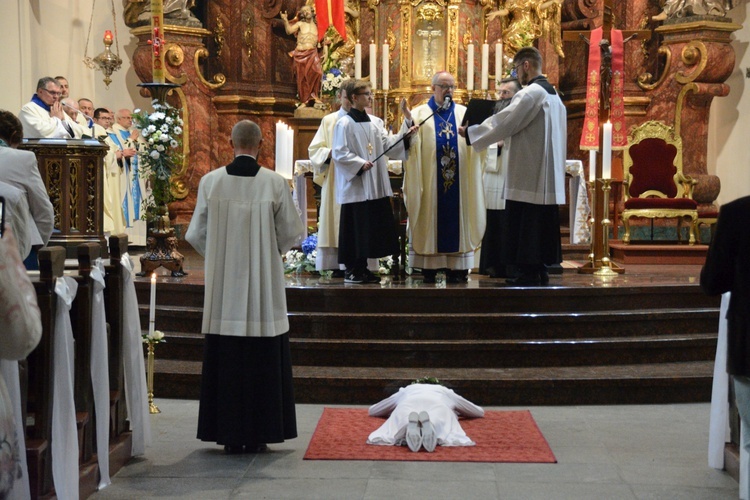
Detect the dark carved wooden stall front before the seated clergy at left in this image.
<box><xmin>19</xmin><ymin>139</ymin><xmax>109</xmax><ymax>259</ymax></box>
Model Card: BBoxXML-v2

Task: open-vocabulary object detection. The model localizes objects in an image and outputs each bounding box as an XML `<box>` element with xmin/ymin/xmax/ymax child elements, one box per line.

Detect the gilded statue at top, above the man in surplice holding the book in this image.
<box><xmin>486</xmin><ymin>0</ymin><xmax>565</xmax><ymax>58</ymax></box>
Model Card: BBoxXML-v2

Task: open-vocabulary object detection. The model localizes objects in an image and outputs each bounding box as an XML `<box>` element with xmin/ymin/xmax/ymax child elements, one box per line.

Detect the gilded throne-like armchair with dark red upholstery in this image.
<box><xmin>622</xmin><ymin>121</ymin><xmax>698</xmax><ymax>245</ymax></box>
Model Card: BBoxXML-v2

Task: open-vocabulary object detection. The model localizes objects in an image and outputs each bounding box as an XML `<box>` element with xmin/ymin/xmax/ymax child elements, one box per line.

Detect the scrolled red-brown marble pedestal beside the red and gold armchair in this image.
<box><xmin>641</xmin><ymin>16</ymin><xmax>741</xmax><ymax>208</ymax></box>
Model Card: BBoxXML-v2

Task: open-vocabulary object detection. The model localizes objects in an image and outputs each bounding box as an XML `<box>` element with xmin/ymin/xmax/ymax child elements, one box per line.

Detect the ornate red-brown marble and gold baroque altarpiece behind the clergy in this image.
<box><xmin>130</xmin><ymin>0</ymin><xmax>740</xmax><ymax>224</ymax></box>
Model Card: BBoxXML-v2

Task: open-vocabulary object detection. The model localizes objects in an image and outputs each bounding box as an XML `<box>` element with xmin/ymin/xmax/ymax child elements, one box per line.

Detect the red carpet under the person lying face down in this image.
<box><xmin>305</xmin><ymin>408</ymin><xmax>557</xmax><ymax>463</ymax></box>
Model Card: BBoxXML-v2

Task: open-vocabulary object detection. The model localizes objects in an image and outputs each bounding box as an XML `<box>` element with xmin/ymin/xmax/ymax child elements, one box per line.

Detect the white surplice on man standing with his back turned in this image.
<box><xmin>185</xmin><ymin>167</ymin><xmax>305</xmax><ymax>337</ymax></box>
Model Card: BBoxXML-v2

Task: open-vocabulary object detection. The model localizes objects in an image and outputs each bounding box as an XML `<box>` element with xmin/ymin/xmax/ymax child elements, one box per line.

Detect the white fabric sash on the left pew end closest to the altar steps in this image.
<box><xmin>120</xmin><ymin>253</ymin><xmax>151</xmax><ymax>457</ymax></box>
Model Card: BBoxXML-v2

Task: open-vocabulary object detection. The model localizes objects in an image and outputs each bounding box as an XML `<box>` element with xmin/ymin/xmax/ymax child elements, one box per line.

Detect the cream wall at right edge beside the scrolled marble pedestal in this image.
<box><xmin>707</xmin><ymin>2</ymin><xmax>750</xmax><ymax>204</ymax></box>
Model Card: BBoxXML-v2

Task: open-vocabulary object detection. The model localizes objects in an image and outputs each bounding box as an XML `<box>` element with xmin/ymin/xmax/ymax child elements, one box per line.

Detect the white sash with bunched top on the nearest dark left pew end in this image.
<box><xmin>51</xmin><ymin>276</ymin><xmax>78</xmax><ymax>499</ymax></box>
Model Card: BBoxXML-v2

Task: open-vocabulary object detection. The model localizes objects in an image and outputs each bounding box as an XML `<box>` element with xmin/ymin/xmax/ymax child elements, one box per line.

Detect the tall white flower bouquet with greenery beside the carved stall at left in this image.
<box><xmin>133</xmin><ymin>99</ymin><xmax>183</xmax><ymax>214</ymax></box>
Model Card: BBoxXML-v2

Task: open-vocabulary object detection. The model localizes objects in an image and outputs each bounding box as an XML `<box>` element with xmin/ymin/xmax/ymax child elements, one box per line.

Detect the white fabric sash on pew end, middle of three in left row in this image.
<box><xmin>91</xmin><ymin>259</ymin><xmax>112</xmax><ymax>489</ymax></box>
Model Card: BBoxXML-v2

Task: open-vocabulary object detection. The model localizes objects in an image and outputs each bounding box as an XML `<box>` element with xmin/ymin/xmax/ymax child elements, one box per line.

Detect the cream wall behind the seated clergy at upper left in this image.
<box><xmin>0</xmin><ymin>0</ymin><xmax>148</xmax><ymax>117</ymax></box>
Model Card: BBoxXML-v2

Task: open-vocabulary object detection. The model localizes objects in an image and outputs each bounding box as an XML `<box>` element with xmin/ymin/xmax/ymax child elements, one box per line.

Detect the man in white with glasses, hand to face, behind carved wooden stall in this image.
<box><xmin>18</xmin><ymin>76</ymin><xmax>80</xmax><ymax>139</ymax></box>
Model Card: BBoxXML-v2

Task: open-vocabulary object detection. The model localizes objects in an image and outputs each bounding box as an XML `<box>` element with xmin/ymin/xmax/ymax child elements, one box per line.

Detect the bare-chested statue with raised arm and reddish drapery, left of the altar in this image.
<box><xmin>280</xmin><ymin>5</ymin><xmax>323</xmax><ymax>106</ymax></box>
